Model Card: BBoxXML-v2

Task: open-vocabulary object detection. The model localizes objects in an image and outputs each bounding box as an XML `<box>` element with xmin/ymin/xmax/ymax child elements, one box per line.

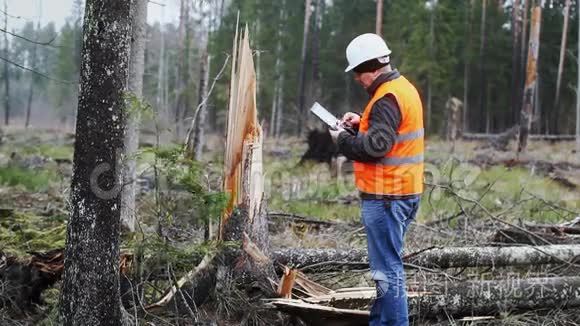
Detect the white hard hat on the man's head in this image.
<box><xmin>344</xmin><ymin>33</ymin><xmax>391</xmax><ymax>72</ymax></box>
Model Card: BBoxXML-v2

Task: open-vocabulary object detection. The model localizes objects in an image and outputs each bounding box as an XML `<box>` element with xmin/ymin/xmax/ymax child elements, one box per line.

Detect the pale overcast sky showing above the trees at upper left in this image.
<box><xmin>5</xmin><ymin>0</ymin><xmax>179</xmax><ymax>30</ymax></box>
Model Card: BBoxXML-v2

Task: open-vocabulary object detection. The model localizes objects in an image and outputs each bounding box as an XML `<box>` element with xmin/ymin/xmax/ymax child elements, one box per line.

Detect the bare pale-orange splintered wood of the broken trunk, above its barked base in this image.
<box><xmin>220</xmin><ymin>27</ymin><xmax>263</xmax><ymax>238</ymax></box>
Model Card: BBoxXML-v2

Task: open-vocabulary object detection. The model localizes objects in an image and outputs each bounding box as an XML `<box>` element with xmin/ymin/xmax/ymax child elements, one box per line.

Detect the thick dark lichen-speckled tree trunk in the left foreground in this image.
<box><xmin>59</xmin><ymin>0</ymin><xmax>131</xmax><ymax>326</ymax></box>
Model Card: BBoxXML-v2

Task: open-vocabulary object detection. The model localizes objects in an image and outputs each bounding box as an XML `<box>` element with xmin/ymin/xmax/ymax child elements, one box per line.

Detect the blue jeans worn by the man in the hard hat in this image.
<box><xmin>361</xmin><ymin>196</ymin><xmax>419</xmax><ymax>326</ymax></box>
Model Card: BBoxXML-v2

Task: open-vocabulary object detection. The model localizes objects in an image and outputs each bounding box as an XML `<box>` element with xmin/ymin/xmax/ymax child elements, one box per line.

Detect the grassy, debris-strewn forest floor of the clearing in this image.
<box><xmin>0</xmin><ymin>130</ymin><xmax>580</xmax><ymax>325</ymax></box>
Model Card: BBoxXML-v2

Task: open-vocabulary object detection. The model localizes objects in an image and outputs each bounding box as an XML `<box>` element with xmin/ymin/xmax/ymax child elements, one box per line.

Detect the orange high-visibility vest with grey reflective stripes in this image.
<box><xmin>354</xmin><ymin>76</ymin><xmax>425</xmax><ymax>196</ymax></box>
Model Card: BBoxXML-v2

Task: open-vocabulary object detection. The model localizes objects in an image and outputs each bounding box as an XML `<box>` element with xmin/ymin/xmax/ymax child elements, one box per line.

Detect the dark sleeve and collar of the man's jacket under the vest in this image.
<box><xmin>337</xmin><ymin>70</ymin><xmax>401</xmax><ymax>163</ymax></box>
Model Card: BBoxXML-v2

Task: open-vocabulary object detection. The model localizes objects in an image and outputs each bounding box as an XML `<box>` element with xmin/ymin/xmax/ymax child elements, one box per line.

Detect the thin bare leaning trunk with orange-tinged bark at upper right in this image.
<box><xmin>518</xmin><ymin>0</ymin><xmax>542</xmax><ymax>153</ymax></box>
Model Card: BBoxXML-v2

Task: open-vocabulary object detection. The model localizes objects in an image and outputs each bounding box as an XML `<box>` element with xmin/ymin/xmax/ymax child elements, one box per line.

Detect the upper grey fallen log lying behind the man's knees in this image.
<box><xmin>272</xmin><ymin>245</ymin><xmax>580</xmax><ymax>269</ymax></box>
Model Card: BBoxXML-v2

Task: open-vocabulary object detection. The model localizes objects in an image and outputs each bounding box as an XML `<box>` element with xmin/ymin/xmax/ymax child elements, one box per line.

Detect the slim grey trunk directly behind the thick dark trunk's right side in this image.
<box><xmin>121</xmin><ymin>0</ymin><xmax>148</xmax><ymax>232</ymax></box>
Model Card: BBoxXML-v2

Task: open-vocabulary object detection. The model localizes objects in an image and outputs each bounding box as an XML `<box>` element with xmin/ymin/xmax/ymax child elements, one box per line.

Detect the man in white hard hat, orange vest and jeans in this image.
<box><xmin>330</xmin><ymin>34</ymin><xmax>424</xmax><ymax>326</ymax></box>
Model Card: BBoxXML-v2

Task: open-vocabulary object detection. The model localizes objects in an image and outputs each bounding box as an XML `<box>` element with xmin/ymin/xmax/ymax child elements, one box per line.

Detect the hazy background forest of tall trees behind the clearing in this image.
<box><xmin>0</xmin><ymin>0</ymin><xmax>578</xmax><ymax>139</ymax></box>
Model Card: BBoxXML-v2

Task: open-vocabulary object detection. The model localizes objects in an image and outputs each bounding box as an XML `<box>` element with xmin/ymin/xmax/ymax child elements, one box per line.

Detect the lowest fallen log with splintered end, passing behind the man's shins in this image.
<box><xmin>270</xmin><ymin>277</ymin><xmax>580</xmax><ymax>326</ymax></box>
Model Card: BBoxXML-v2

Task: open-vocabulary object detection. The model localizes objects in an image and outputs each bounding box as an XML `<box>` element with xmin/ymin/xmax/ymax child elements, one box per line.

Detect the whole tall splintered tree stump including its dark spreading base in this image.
<box><xmin>149</xmin><ymin>28</ymin><xmax>275</xmax><ymax>313</ymax></box>
